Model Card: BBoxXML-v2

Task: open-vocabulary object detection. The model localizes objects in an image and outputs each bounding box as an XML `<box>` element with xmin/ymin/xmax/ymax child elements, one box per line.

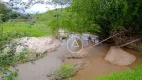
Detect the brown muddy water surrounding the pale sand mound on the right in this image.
<box><xmin>65</xmin><ymin>45</ymin><xmax>142</xmax><ymax>80</ymax></box>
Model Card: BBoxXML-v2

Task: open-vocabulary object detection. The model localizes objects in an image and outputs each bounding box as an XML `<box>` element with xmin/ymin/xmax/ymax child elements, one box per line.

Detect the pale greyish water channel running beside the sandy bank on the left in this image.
<box><xmin>16</xmin><ymin>41</ymin><xmax>69</xmax><ymax>80</ymax></box>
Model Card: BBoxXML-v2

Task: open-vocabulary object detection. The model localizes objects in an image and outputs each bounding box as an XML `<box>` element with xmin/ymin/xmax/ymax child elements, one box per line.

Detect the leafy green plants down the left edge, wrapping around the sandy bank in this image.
<box><xmin>0</xmin><ymin>28</ymin><xmax>40</xmax><ymax>80</ymax></box>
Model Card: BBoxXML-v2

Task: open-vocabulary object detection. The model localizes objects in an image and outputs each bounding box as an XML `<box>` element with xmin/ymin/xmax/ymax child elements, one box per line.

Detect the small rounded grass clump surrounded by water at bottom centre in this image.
<box><xmin>55</xmin><ymin>64</ymin><xmax>77</xmax><ymax>80</ymax></box>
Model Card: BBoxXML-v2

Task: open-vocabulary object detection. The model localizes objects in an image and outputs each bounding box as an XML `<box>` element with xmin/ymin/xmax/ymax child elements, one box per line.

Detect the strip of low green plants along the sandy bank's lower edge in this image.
<box><xmin>0</xmin><ymin>50</ymin><xmax>42</xmax><ymax>72</ymax></box>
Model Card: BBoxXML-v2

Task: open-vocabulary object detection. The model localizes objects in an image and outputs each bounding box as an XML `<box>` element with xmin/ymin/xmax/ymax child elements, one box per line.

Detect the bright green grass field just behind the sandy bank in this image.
<box><xmin>2</xmin><ymin>22</ymin><xmax>51</xmax><ymax>37</ymax></box>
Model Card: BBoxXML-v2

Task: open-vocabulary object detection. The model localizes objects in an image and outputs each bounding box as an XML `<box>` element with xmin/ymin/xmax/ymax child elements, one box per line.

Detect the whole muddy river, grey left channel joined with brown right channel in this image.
<box><xmin>17</xmin><ymin>40</ymin><xmax>142</xmax><ymax>80</ymax></box>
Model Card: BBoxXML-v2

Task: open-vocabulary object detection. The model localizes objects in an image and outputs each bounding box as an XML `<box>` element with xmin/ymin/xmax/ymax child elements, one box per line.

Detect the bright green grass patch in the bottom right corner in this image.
<box><xmin>93</xmin><ymin>65</ymin><xmax>142</xmax><ymax>80</ymax></box>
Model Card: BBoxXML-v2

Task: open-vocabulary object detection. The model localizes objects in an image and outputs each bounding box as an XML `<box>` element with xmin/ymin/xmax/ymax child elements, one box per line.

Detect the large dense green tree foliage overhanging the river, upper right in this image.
<box><xmin>48</xmin><ymin>0</ymin><xmax>142</xmax><ymax>41</ymax></box>
